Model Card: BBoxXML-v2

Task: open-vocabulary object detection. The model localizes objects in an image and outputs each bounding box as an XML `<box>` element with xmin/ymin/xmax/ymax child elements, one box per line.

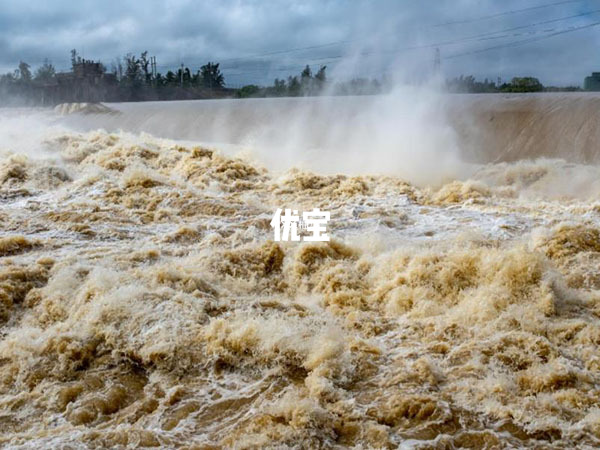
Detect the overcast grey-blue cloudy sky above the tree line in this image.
<box><xmin>0</xmin><ymin>0</ymin><xmax>600</xmax><ymax>86</ymax></box>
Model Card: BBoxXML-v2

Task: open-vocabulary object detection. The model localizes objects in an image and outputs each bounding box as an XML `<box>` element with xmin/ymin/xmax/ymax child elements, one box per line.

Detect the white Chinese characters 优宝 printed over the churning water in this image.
<box><xmin>271</xmin><ymin>208</ymin><xmax>331</xmax><ymax>242</ymax></box>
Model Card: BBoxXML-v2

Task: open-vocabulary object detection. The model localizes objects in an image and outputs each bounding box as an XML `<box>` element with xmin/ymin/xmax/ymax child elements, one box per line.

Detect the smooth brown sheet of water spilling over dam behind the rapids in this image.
<box><xmin>57</xmin><ymin>92</ymin><xmax>600</xmax><ymax>163</ymax></box>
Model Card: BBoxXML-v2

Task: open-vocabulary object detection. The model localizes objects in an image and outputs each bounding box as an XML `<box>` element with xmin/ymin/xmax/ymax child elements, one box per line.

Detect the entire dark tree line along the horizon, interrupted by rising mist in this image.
<box><xmin>0</xmin><ymin>50</ymin><xmax>579</xmax><ymax>105</ymax></box>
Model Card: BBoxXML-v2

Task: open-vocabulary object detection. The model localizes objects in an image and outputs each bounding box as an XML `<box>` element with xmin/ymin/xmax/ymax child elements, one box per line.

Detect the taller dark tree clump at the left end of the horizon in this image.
<box><xmin>0</xmin><ymin>50</ymin><xmax>235</xmax><ymax>105</ymax></box>
